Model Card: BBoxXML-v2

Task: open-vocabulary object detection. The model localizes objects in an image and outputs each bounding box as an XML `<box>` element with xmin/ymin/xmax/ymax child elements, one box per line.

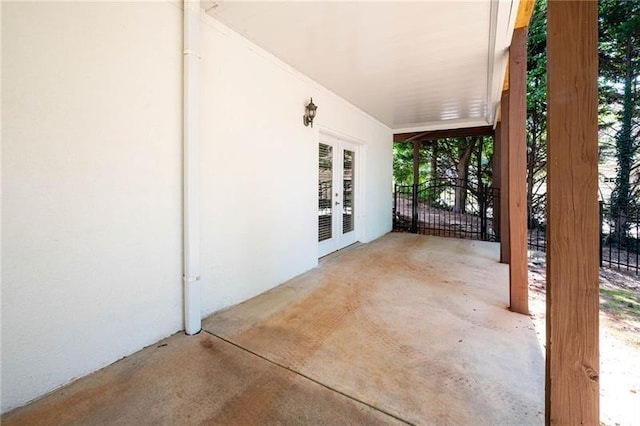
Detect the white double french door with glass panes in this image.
<box><xmin>318</xmin><ymin>134</ymin><xmax>359</xmax><ymax>257</ymax></box>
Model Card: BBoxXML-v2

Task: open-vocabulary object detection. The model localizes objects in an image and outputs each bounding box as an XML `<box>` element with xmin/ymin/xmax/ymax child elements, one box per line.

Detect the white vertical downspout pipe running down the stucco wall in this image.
<box><xmin>182</xmin><ymin>0</ymin><xmax>202</xmax><ymax>334</ymax></box>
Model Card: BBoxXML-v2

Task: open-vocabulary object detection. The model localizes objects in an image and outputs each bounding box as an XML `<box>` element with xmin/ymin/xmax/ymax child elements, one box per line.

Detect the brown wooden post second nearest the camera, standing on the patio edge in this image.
<box><xmin>508</xmin><ymin>27</ymin><xmax>529</xmax><ymax>314</ymax></box>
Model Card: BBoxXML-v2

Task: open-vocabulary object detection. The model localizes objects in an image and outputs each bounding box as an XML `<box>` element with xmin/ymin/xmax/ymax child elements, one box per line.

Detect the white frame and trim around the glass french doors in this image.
<box><xmin>316</xmin><ymin>129</ymin><xmax>364</xmax><ymax>257</ymax></box>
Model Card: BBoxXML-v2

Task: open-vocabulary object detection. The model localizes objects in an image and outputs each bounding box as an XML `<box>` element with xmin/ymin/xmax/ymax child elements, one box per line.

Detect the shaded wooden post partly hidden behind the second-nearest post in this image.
<box><xmin>500</xmin><ymin>90</ymin><xmax>509</xmax><ymax>263</ymax></box>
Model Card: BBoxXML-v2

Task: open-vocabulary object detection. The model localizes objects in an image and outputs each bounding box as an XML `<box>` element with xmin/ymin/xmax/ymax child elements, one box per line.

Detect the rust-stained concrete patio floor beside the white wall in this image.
<box><xmin>2</xmin><ymin>234</ymin><xmax>544</xmax><ymax>425</ymax></box>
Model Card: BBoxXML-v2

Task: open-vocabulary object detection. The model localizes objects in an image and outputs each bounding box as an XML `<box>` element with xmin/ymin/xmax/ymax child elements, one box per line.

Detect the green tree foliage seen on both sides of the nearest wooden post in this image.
<box><xmin>527</xmin><ymin>0</ymin><xmax>640</xmax><ymax>231</ymax></box>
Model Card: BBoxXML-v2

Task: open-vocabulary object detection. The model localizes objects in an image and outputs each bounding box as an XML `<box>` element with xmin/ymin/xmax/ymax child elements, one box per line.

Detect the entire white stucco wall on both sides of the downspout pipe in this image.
<box><xmin>1</xmin><ymin>2</ymin><xmax>392</xmax><ymax>412</ymax></box>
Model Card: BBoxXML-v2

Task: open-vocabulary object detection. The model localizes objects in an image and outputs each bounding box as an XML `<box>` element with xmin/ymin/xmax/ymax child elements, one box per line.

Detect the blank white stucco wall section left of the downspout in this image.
<box><xmin>2</xmin><ymin>2</ymin><xmax>182</xmax><ymax>411</ymax></box>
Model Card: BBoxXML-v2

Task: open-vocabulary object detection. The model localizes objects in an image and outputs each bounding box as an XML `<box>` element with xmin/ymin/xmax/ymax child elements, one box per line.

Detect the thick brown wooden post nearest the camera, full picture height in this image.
<box><xmin>546</xmin><ymin>0</ymin><xmax>600</xmax><ymax>425</ymax></box>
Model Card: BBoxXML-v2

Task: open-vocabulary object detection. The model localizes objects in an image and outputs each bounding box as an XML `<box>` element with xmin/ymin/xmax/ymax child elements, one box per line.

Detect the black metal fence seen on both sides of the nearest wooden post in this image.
<box><xmin>529</xmin><ymin>202</ymin><xmax>640</xmax><ymax>274</ymax></box>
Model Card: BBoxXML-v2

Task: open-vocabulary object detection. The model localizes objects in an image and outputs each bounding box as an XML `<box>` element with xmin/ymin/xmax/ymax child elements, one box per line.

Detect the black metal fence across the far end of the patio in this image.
<box><xmin>393</xmin><ymin>179</ymin><xmax>499</xmax><ymax>241</ymax></box>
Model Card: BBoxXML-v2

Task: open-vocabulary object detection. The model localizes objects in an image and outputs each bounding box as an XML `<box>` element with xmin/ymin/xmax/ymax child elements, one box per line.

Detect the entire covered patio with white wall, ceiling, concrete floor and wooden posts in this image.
<box><xmin>0</xmin><ymin>0</ymin><xmax>599</xmax><ymax>424</ymax></box>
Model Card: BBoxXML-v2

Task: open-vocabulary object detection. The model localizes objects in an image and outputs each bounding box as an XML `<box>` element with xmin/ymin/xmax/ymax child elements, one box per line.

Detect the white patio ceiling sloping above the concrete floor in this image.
<box><xmin>202</xmin><ymin>0</ymin><xmax>518</xmax><ymax>133</ymax></box>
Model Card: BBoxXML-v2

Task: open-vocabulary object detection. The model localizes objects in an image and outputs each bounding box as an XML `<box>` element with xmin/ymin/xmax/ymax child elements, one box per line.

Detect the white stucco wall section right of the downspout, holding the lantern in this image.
<box><xmin>201</xmin><ymin>15</ymin><xmax>392</xmax><ymax>314</ymax></box>
